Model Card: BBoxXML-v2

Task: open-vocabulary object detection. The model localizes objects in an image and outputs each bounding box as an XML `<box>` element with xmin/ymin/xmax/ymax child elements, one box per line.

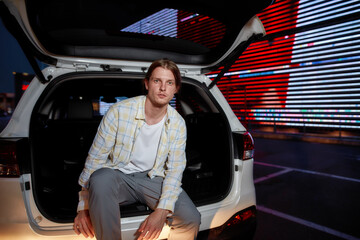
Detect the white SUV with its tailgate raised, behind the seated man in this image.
<box><xmin>0</xmin><ymin>0</ymin><xmax>271</xmax><ymax>239</ymax></box>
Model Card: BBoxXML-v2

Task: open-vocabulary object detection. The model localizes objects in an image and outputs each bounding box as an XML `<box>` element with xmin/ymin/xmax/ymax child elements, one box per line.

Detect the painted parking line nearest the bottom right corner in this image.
<box><xmin>256</xmin><ymin>205</ymin><xmax>360</xmax><ymax>240</ymax></box>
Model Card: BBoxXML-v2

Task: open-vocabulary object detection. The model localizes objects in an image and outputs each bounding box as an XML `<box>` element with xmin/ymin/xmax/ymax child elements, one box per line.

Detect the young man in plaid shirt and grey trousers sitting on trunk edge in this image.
<box><xmin>74</xmin><ymin>60</ymin><xmax>200</xmax><ymax>240</ymax></box>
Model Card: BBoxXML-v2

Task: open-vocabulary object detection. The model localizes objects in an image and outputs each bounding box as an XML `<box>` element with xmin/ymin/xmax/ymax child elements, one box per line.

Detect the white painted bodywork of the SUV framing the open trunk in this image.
<box><xmin>0</xmin><ymin>0</ymin><xmax>271</xmax><ymax>239</ymax></box>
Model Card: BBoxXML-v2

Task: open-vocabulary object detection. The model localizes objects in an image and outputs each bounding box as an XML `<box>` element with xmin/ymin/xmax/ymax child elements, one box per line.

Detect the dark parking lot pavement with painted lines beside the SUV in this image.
<box><xmin>254</xmin><ymin>138</ymin><xmax>360</xmax><ymax>240</ymax></box>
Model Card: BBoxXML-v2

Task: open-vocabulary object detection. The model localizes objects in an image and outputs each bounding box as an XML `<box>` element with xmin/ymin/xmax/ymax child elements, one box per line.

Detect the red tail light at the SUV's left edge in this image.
<box><xmin>0</xmin><ymin>138</ymin><xmax>26</xmax><ymax>177</ymax></box>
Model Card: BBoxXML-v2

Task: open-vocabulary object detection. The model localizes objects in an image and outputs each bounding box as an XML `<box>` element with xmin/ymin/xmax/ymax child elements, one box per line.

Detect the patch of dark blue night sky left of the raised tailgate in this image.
<box><xmin>0</xmin><ymin>17</ymin><xmax>34</xmax><ymax>93</ymax></box>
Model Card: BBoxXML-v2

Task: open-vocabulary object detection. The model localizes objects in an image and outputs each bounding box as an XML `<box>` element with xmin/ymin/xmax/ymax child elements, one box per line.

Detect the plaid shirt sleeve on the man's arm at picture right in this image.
<box><xmin>157</xmin><ymin>118</ymin><xmax>186</xmax><ymax>213</ymax></box>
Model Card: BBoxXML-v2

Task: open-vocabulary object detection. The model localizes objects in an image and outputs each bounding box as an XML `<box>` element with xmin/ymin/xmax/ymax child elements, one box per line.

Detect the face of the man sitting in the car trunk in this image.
<box><xmin>145</xmin><ymin>67</ymin><xmax>177</xmax><ymax>107</ymax></box>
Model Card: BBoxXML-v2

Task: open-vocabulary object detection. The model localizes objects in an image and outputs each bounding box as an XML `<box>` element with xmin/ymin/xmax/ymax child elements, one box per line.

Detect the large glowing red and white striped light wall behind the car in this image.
<box><xmin>208</xmin><ymin>0</ymin><xmax>360</xmax><ymax>130</ymax></box>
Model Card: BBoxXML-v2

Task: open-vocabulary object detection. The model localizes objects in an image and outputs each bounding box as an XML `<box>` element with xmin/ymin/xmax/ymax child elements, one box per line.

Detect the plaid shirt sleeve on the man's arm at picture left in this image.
<box><xmin>78</xmin><ymin>105</ymin><xmax>118</xmax><ymax>188</ymax></box>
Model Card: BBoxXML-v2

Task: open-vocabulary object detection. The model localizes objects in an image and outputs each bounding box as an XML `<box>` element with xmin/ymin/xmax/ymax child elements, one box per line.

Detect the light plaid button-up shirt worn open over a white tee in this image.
<box><xmin>78</xmin><ymin>96</ymin><xmax>186</xmax><ymax>212</ymax></box>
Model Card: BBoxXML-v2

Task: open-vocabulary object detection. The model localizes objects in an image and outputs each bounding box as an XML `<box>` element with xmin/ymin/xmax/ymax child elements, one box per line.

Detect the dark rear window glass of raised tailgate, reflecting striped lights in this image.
<box><xmin>26</xmin><ymin>0</ymin><xmax>271</xmax><ymax>64</ymax></box>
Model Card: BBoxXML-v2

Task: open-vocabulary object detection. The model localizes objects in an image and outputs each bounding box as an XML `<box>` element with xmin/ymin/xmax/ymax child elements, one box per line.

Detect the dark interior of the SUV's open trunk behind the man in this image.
<box><xmin>30</xmin><ymin>72</ymin><xmax>233</xmax><ymax>222</ymax></box>
